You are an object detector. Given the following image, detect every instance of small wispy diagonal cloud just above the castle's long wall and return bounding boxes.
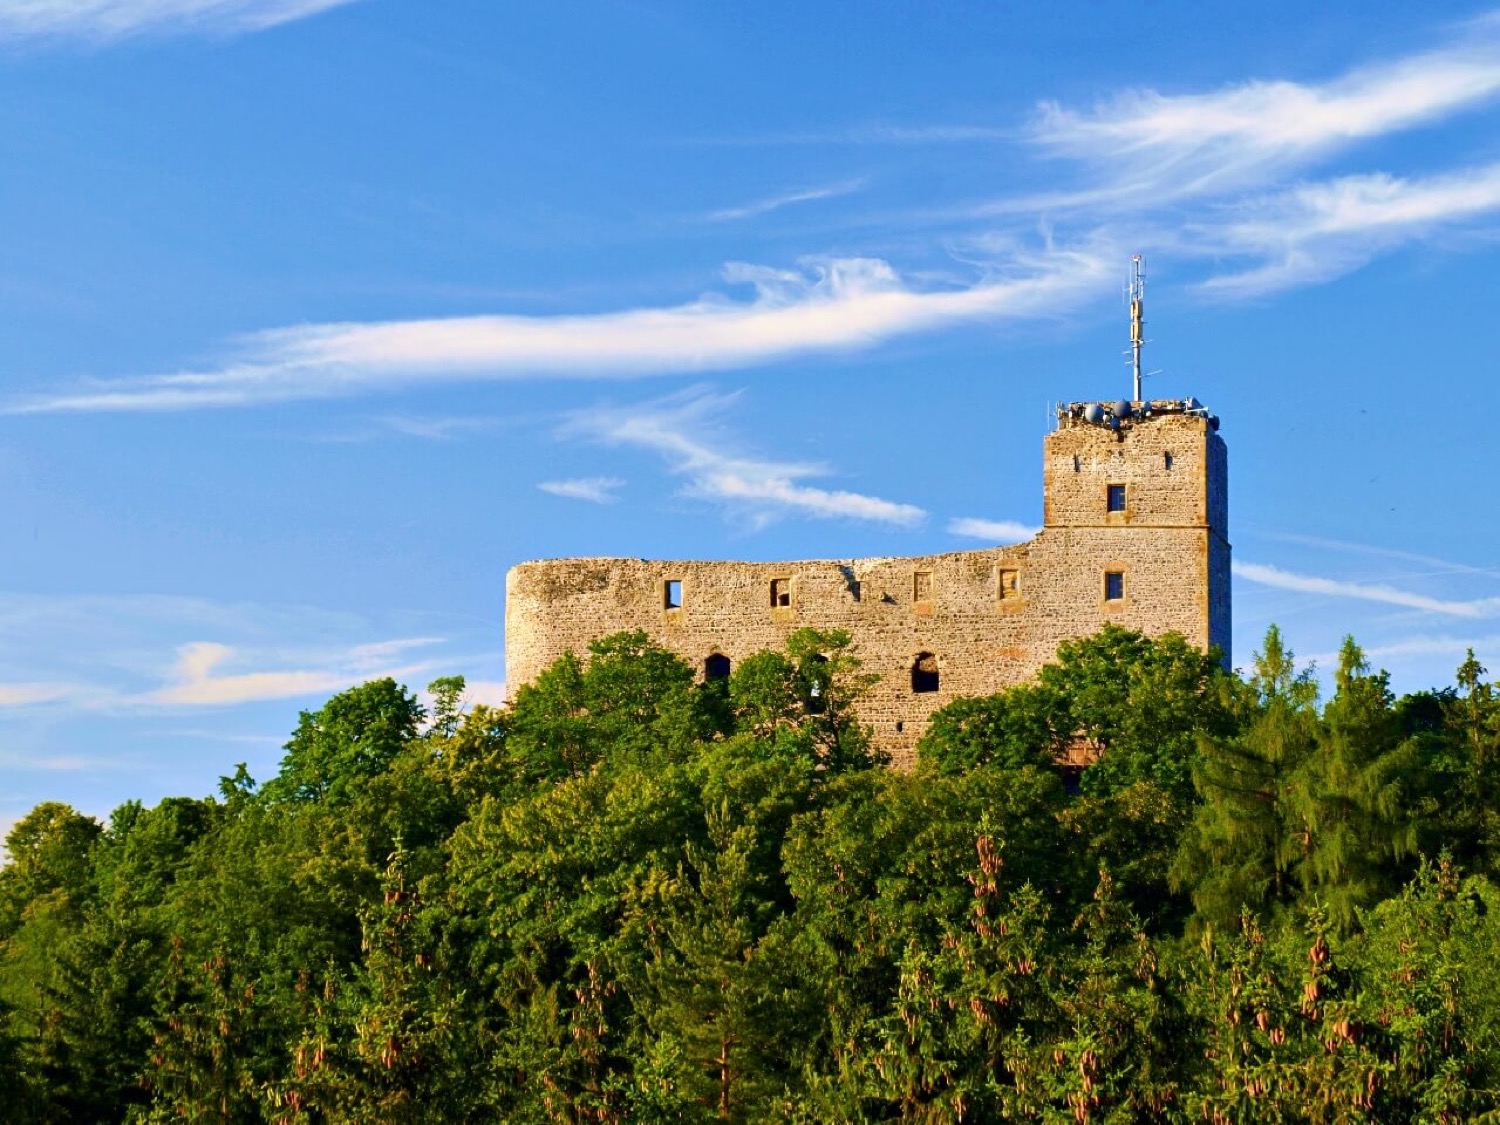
[564,390,927,527]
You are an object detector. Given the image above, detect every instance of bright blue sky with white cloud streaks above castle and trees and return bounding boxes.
[0,0,1500,828]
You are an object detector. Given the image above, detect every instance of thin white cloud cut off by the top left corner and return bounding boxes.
[0,0,354,42]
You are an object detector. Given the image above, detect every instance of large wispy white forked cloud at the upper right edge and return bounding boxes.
[1002,17,1500,300]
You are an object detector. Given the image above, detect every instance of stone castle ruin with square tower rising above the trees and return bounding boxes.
[506,399,1230,765]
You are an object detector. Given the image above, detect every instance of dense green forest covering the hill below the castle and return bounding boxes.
[0,627,1500,1125]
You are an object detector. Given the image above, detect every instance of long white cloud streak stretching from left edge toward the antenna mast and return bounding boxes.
[5,251,1112,414]
